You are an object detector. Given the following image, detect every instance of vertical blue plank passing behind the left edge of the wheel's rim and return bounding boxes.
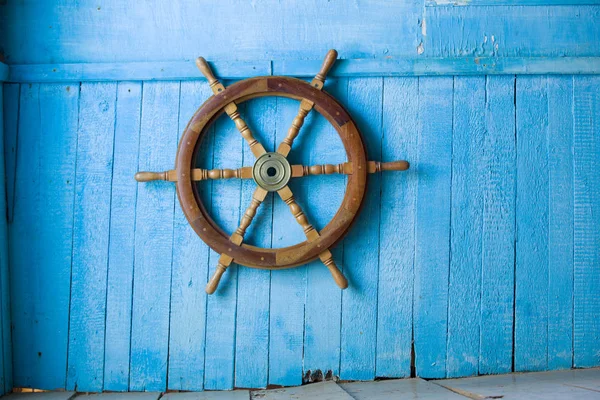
[168,81,212,390]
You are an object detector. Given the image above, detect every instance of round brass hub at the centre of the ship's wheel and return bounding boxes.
[252,153,292,192]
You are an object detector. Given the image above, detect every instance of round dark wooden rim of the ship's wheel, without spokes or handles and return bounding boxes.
[175,76,367,269]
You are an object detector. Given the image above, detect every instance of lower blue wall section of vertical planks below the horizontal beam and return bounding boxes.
[4,76,600,391]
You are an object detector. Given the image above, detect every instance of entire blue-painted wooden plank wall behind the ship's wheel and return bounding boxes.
[0,0,600,391]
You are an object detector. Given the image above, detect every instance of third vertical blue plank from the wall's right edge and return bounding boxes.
[514,77,549,371]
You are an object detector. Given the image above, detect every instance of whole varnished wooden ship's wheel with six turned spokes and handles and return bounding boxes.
[136,50,408,294]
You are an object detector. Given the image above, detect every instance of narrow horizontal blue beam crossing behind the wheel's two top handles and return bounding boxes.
[0,57,600,82]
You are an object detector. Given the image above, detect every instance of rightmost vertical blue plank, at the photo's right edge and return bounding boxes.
[573,77,600,368]
